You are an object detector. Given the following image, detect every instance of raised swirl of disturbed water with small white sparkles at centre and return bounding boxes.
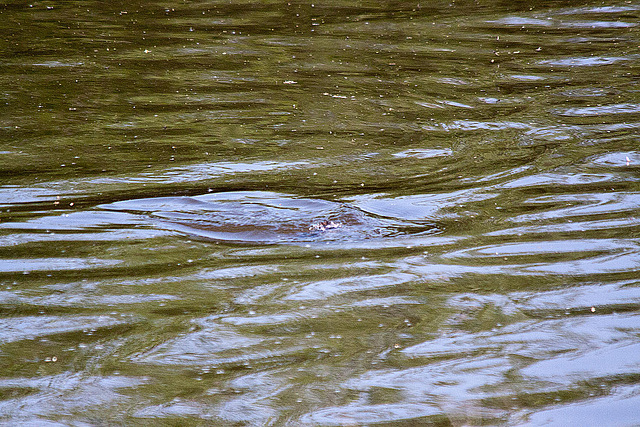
[100,191,433,243]
